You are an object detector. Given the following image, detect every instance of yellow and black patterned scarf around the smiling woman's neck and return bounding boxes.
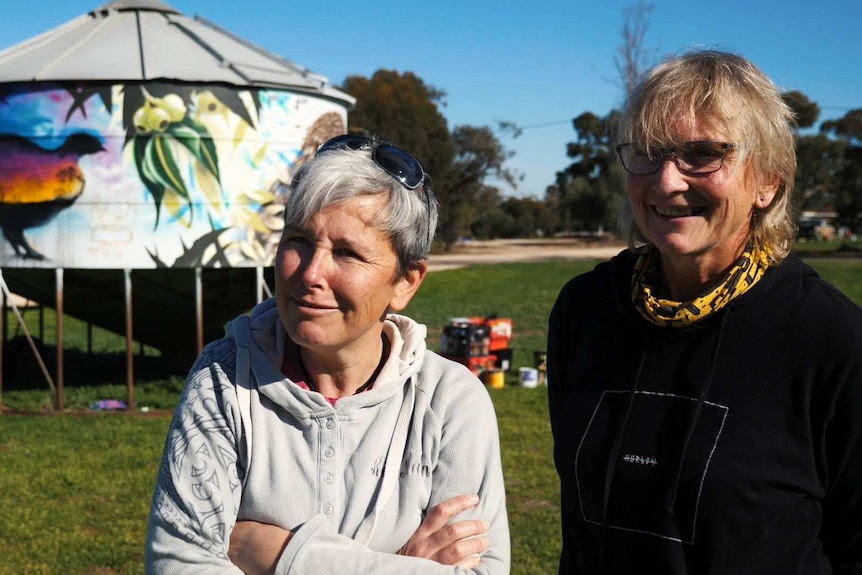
[632,246,769,327]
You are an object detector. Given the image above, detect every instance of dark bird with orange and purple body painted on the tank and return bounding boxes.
[0,132,105,260]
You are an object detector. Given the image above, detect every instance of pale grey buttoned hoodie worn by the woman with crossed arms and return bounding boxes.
[146,299,510,575]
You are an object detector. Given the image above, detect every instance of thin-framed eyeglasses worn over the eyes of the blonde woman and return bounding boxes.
[617,142,736,176]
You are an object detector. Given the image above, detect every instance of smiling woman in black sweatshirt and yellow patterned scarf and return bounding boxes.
[547,50,862,575]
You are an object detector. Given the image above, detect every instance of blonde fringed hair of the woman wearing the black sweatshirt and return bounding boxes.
[616,50,796,263]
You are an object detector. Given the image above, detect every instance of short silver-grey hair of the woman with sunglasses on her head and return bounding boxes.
[284,148,439,278]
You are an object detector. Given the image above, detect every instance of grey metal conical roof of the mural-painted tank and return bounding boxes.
[0,0,355,105]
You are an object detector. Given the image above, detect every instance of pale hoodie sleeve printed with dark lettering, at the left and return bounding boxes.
[145,357,244,575]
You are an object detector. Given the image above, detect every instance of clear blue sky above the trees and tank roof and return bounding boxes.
[0,0,862,198]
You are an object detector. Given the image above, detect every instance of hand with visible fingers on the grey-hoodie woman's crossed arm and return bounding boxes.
[398,495,490,569]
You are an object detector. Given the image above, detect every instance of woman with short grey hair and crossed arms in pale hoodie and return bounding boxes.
[146,135,509,575]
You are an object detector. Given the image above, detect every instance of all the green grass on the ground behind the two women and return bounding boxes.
[0,258,862,575]
